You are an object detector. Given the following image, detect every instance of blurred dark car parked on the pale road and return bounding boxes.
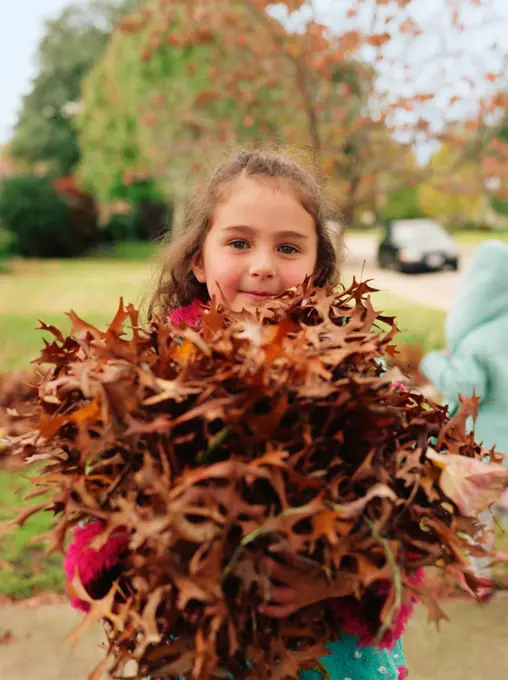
[378,219,459,273]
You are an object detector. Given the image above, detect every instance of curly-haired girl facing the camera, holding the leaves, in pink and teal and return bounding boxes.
[65,151,420,680]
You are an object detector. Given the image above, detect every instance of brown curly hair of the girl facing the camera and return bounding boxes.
[148,149,341,319]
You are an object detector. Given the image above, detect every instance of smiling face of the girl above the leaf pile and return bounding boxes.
[192,178,318,311]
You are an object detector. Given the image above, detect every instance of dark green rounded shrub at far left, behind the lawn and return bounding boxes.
[0,175,98,257]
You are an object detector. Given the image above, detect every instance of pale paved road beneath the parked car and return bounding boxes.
[344,236,474,311]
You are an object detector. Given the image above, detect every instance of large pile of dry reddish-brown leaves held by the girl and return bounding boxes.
[6,282,508,680]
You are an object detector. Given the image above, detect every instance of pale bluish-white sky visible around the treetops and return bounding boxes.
[0,0,508,144]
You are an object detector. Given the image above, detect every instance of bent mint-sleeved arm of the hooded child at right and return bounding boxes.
[420,352,487,403]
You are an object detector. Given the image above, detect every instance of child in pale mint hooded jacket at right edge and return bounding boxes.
[420,241,508,599]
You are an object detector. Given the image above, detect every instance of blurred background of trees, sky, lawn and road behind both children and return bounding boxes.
[0,0,508,680]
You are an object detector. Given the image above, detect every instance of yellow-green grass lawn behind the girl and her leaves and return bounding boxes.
[0,249,443,597]
